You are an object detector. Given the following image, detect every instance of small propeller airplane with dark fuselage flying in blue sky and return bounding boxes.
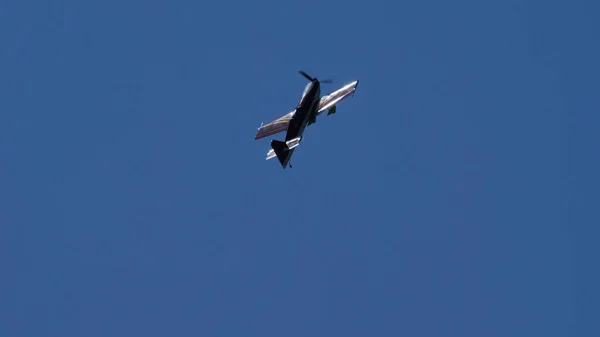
[254,70,358,169]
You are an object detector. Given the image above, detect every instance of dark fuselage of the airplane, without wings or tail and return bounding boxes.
[285,80,321,142]
